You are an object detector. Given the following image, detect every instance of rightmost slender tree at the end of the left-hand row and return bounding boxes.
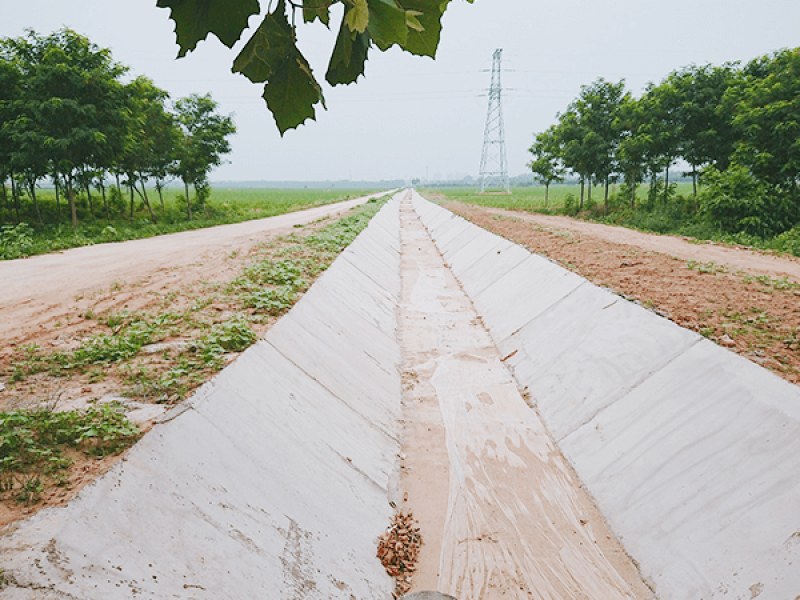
[174,94,236,219]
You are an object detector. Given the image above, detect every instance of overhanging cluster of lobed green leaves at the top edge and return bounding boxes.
[157,0,473,135]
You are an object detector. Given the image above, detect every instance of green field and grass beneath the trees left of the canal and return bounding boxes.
[0,187,388,260]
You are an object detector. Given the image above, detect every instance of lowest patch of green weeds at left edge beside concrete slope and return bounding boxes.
[0,404,140,503]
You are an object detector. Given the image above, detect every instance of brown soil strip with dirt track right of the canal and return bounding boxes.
[438,196,800,384]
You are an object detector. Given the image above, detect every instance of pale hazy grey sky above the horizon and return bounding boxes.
[0,0,800,181]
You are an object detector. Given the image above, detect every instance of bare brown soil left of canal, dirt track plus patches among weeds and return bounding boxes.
[0,198,376,528]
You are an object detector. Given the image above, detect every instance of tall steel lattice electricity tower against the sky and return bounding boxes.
[479,48,511,194]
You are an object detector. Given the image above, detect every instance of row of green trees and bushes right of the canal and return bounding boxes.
[530,50,800,235]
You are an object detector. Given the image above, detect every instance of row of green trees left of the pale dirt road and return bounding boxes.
[0,29,236,226]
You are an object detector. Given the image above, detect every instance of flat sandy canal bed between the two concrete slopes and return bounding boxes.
[399,201,651,600]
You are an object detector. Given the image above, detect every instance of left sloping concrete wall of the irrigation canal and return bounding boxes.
[0,197,401,600]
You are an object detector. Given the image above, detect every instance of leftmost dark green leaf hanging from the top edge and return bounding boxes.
[156,0,259,57]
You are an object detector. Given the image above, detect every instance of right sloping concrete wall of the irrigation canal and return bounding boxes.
[414,195,800,600]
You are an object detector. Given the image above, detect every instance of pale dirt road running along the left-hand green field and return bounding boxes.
[0,196,378,347]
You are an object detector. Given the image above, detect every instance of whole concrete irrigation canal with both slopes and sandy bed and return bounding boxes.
[0,191,800,600]
